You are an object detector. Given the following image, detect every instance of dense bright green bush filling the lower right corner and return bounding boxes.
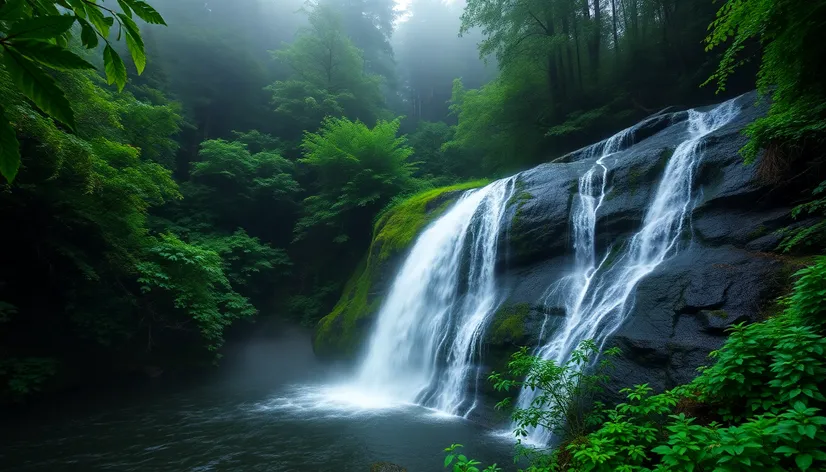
[448,294,826,472]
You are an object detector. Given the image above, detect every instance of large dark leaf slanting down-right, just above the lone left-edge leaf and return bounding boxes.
[3,49,75,130]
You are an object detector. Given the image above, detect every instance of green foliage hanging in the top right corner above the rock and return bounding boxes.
[706,0,826,162]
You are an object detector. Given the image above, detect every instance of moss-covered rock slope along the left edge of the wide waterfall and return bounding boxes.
[313,180,488,357]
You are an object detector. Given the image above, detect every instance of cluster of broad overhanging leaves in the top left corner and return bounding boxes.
[0,0,165,182]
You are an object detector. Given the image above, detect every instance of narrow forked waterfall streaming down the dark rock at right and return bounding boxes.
[517,100,738,444]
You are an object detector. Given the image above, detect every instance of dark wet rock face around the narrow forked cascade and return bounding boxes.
[485,89,792,399]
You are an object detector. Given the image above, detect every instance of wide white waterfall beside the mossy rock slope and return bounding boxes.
[355,176,516,415]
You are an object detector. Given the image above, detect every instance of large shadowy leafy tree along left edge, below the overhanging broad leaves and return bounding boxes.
[0,69,188,395]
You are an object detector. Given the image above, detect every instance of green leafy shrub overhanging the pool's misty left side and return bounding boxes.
[137,234,256,351]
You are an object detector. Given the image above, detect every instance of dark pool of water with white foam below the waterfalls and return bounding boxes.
[0,329,513,472]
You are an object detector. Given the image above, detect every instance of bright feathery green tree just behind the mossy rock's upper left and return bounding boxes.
[295,118,414,243]
